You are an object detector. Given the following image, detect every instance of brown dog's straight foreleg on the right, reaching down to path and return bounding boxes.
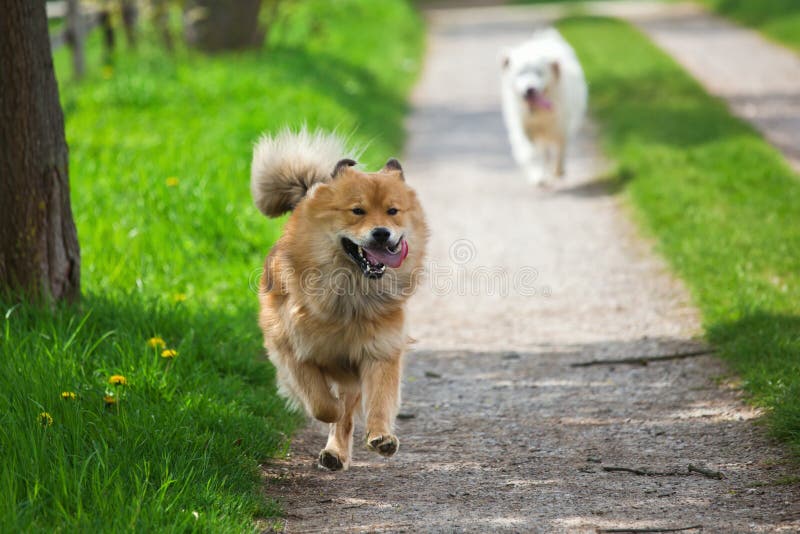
[361,357,401,456]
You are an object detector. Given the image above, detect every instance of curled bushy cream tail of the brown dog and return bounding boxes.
[250,126,360,217]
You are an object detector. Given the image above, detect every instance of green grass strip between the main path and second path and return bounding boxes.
[559,18,800,453]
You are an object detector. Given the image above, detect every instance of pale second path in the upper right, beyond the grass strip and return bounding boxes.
[591,2,800,172]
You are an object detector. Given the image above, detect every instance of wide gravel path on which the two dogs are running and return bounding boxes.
[265,8,800,532]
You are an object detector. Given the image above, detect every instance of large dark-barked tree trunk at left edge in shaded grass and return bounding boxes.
[0,0,80,301]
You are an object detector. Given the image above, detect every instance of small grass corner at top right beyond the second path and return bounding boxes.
[700,0,800,51]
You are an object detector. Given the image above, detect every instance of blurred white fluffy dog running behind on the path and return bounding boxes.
[502,28,588,184]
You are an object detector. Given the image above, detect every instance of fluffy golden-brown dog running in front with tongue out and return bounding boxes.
[251,129,428,470]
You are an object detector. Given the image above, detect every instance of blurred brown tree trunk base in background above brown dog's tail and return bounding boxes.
[183,0,264,52]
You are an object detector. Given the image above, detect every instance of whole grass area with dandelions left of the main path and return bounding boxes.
[0,0,423,532]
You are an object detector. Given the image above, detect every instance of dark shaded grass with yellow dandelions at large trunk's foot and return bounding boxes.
[0,295,299,531]
